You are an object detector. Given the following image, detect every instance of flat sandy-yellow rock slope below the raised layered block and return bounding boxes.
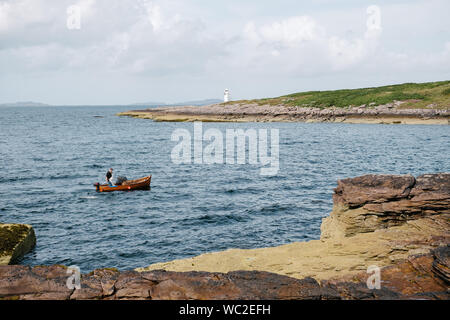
[138,217,449,280]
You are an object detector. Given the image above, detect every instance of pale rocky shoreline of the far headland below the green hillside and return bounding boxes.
[118,101,450,125]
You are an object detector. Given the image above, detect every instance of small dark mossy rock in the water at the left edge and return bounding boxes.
[0,223,36,265]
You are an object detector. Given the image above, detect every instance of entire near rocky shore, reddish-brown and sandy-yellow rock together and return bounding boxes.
[0,173,450,300]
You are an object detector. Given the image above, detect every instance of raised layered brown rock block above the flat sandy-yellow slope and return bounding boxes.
[321,173,450,239]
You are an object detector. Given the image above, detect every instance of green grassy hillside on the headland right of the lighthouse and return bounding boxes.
[235,81,450,109]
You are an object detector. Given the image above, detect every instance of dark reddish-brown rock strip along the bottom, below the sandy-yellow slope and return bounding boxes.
[0,247,450,300]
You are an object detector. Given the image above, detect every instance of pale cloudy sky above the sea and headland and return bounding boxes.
[0,0,450,105]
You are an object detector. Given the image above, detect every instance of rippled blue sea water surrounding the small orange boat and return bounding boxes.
[0,107,450,272]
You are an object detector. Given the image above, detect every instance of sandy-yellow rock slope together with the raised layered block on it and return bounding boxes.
[138,173,450,280]
